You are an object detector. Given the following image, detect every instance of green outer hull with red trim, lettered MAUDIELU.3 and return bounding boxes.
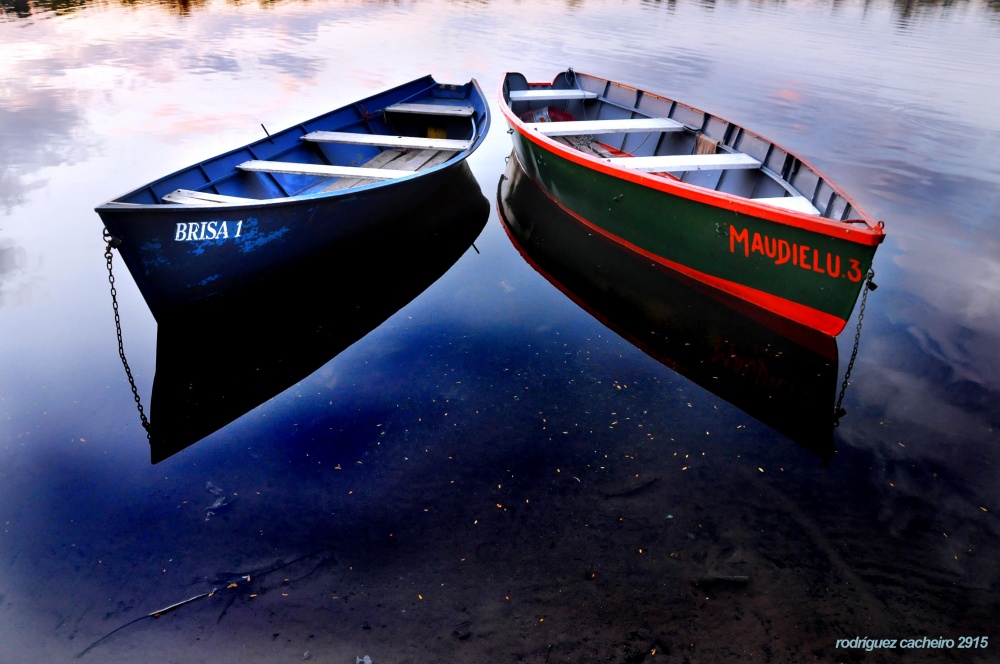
[501,71,883,336]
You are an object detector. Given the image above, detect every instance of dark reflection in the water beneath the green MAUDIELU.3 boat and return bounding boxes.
[497,157,838,463]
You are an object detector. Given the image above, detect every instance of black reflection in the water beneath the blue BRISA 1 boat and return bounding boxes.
[149,164,490,463]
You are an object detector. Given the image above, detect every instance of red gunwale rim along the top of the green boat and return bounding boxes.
[498,72,885,249]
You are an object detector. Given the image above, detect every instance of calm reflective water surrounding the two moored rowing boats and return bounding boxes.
[0,0,1000,664]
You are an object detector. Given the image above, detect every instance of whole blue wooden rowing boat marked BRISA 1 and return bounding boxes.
[96,76,490,319]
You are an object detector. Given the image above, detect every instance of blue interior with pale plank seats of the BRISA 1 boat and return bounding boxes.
[122,85,484,205]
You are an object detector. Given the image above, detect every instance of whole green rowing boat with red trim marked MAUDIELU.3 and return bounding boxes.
[499,69,885,336]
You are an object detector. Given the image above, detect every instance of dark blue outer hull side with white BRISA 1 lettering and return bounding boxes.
[101,169,463,319]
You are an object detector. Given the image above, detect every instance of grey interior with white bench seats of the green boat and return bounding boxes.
[503,70,864,223]
